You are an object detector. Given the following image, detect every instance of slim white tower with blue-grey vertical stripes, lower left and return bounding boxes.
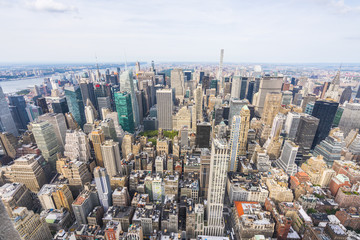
[94,167,112,211]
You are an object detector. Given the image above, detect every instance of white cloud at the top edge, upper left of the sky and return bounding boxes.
[25,0,78,13]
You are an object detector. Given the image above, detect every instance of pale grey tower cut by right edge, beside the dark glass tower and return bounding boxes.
[339,103,360,136]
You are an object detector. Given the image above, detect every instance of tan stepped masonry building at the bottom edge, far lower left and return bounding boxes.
[12,207,52,240]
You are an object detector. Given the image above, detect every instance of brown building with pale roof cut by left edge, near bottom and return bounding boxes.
[0,183,34,217]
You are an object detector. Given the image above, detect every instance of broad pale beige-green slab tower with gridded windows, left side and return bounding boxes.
[31,121,59,169]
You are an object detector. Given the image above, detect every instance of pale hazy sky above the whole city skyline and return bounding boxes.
[0,0,360,63]
